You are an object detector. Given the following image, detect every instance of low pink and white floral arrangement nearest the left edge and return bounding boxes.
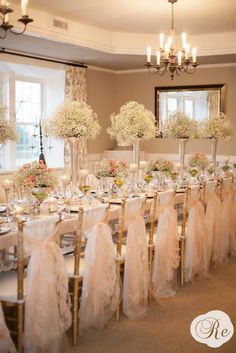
[13,161,57,189]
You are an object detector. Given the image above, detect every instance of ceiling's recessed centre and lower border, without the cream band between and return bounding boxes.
[0,0,236,70]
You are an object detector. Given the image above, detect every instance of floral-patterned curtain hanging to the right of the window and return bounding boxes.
[64,65,87,172]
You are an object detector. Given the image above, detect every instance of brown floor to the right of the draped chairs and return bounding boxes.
[73,257,236,353]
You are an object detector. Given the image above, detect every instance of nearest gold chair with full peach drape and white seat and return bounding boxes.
[0,216,71,353]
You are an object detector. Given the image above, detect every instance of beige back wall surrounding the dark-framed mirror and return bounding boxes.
[88,66,236,155]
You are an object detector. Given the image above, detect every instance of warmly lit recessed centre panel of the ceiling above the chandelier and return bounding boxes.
[30,0,236,34]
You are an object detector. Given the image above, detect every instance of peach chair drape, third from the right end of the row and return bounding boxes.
[184,186,207,282]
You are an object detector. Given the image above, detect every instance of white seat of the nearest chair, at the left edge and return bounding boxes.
[0,271,27,303]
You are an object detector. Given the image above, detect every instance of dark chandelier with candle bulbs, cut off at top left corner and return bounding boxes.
[0,0,33,39]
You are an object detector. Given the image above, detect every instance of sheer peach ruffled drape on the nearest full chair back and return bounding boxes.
[24,217,71,353]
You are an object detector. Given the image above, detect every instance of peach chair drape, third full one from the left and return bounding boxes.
[123,197,148,319]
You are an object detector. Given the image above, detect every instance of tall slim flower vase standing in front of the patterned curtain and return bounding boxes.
[68,137,80,198]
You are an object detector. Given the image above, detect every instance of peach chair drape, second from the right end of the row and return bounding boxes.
[205,181,219,268]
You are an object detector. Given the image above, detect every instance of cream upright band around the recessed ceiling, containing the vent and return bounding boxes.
[14,5,236,56]
